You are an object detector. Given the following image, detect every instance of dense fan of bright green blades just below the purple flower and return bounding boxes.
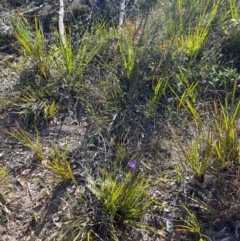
[87,172,153,222]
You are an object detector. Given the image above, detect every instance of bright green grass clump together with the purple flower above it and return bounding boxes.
[81,160,163,240]
